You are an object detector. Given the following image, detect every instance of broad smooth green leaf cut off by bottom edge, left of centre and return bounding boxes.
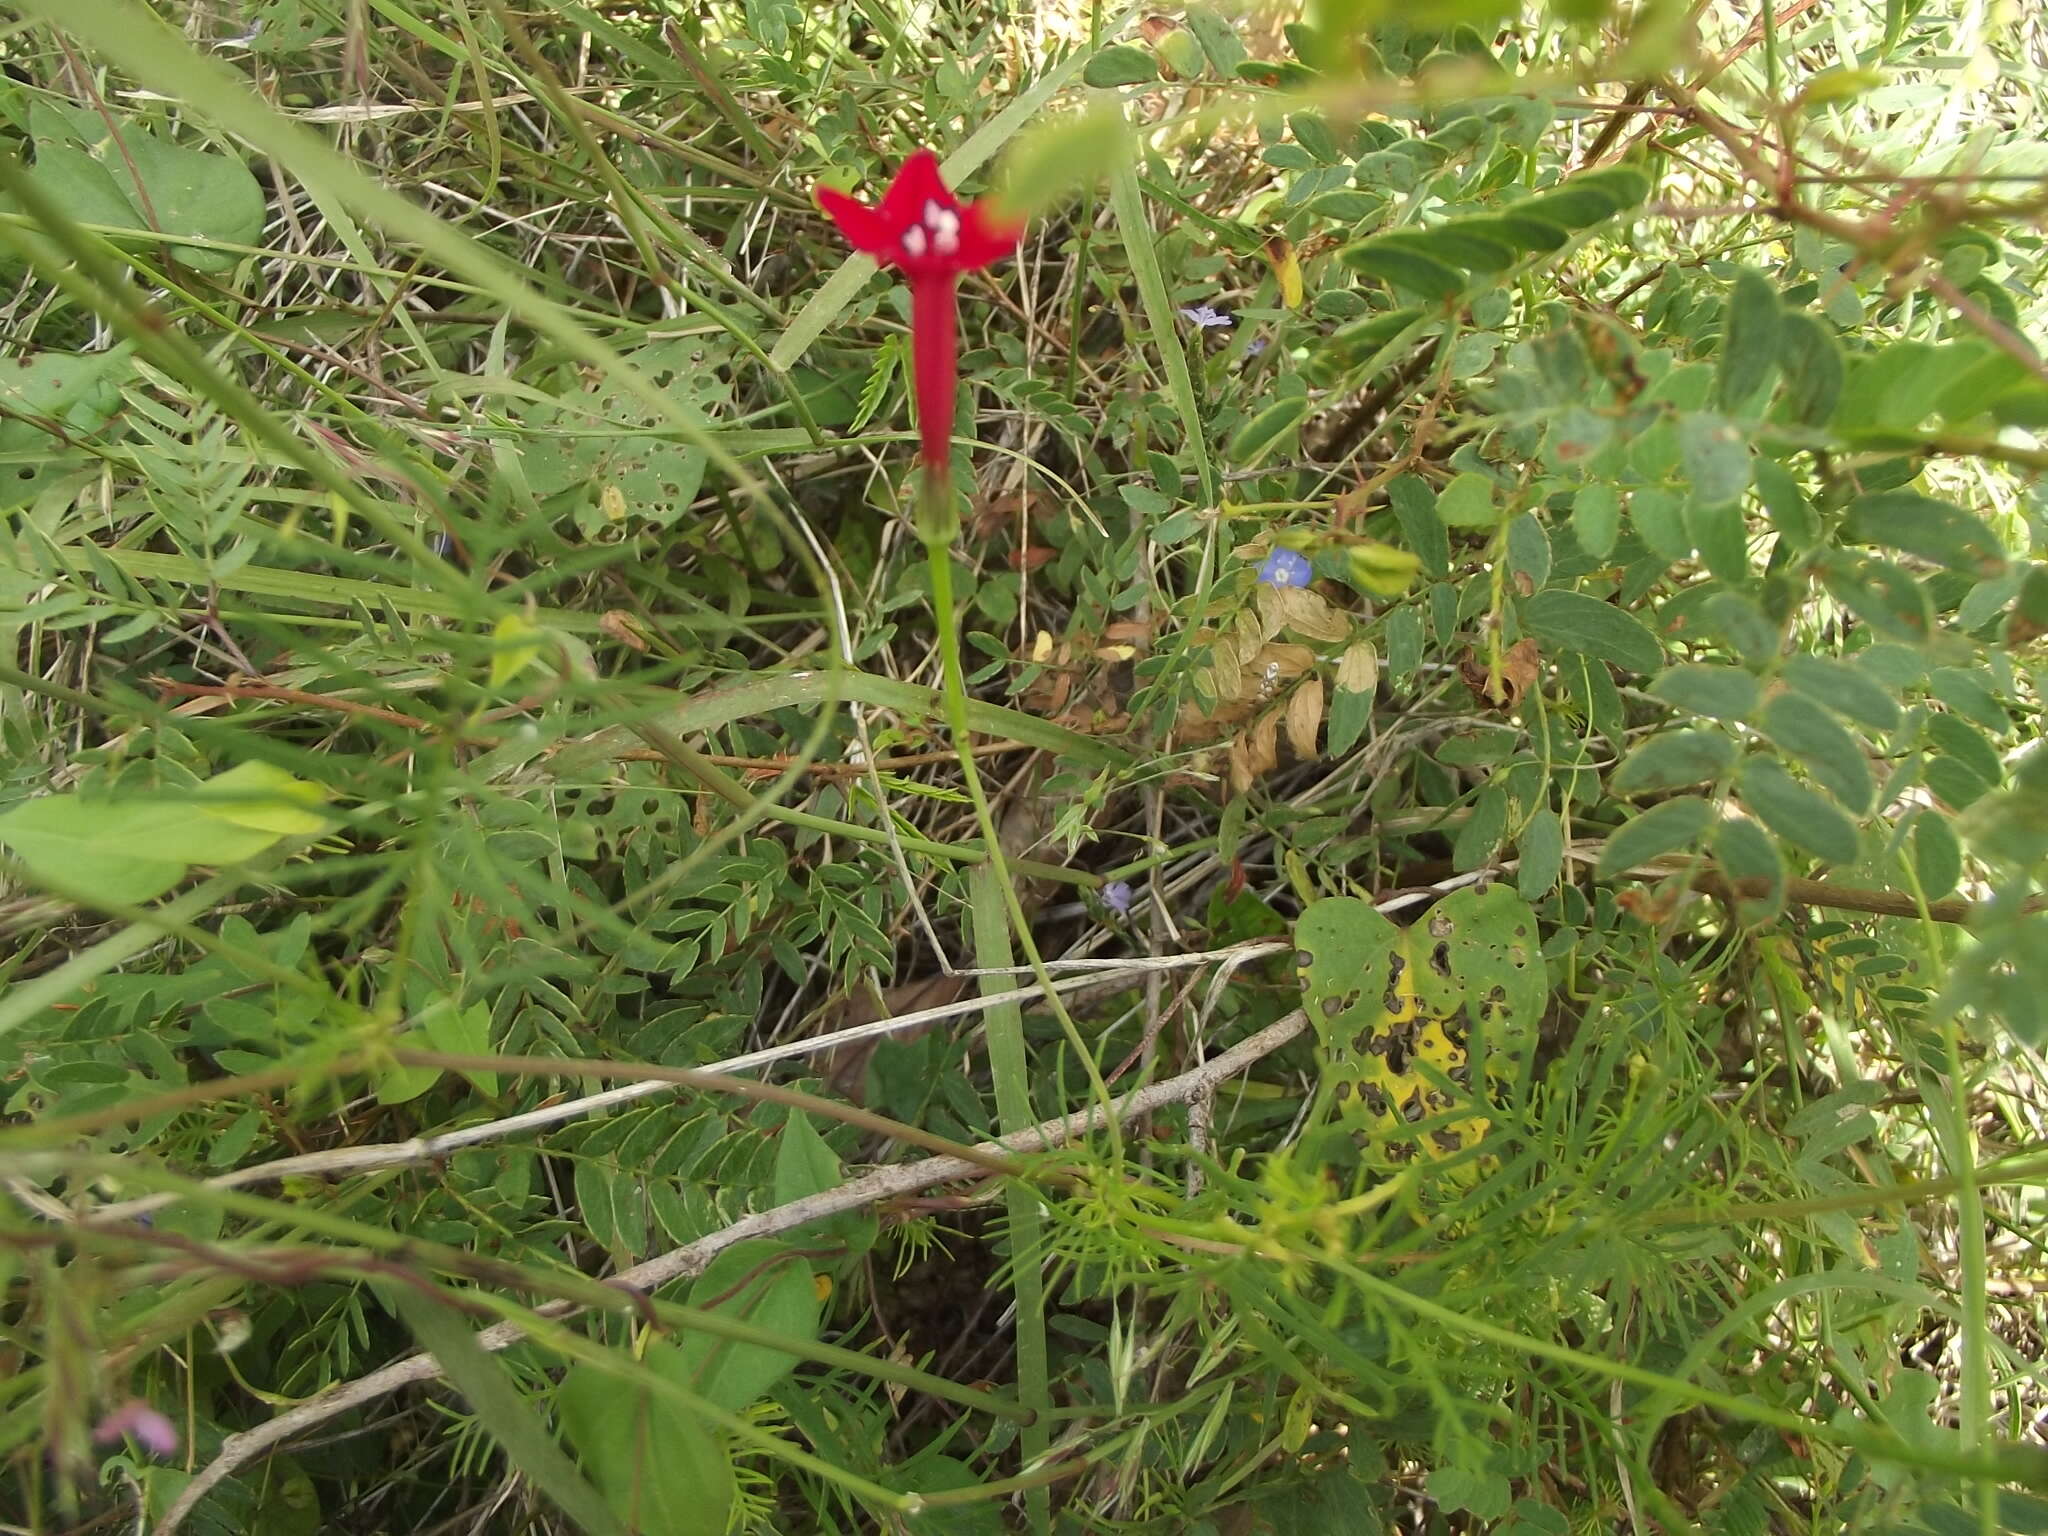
[555,1339,733,1536]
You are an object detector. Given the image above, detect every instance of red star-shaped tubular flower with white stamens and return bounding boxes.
[817,150,1024,481]
